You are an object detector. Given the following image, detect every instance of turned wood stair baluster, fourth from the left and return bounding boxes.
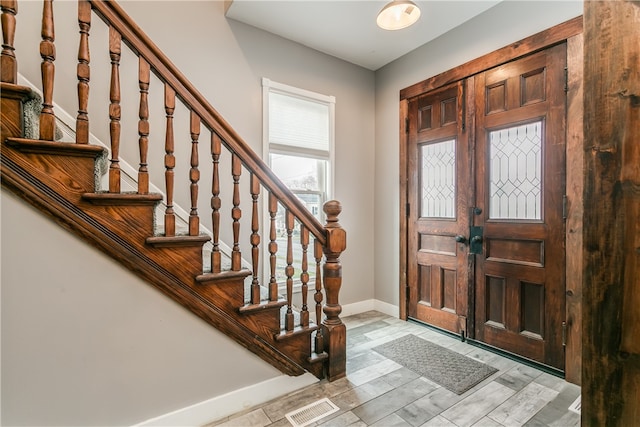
[109,27,122,193]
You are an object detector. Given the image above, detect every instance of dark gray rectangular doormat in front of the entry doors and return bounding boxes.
[373,334,498,394]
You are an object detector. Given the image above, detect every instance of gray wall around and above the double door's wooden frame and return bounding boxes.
[373,1,582,305]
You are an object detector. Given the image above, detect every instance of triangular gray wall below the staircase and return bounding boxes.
[1,195,280,426]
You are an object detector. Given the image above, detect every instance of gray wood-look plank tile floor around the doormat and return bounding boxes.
[207,311,580,427]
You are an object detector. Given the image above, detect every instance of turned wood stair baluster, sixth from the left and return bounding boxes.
[164,83,176,237]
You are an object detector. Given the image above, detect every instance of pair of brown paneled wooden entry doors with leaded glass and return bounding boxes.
[406,44,566,370]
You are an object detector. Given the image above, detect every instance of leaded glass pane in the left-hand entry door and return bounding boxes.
[420,139,456,218]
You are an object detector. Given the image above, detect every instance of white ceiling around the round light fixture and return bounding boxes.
[227,0,502,70]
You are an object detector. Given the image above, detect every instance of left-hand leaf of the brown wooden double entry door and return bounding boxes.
[407,83,470,333]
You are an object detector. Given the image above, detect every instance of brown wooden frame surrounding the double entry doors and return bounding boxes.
[399,16,583,384]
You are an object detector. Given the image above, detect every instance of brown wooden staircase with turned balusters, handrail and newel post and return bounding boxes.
[0,0,346,381]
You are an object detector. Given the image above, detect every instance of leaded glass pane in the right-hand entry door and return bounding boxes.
[489,121,542,220]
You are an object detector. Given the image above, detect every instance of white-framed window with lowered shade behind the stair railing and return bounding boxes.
[262,78,335,283]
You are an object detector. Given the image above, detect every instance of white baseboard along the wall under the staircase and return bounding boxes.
[135,373,319,427]
